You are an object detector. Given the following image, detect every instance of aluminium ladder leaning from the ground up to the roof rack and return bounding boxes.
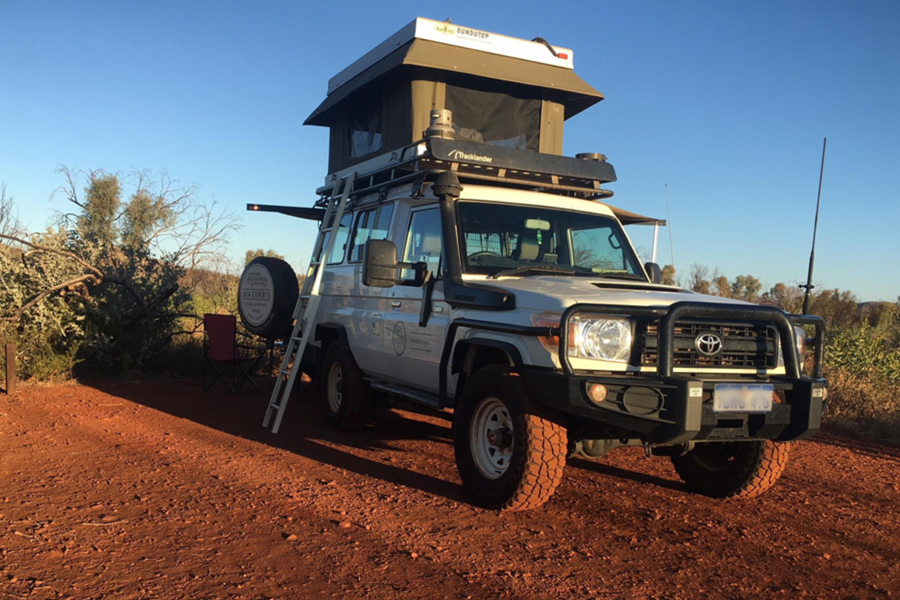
[263,173,356,433]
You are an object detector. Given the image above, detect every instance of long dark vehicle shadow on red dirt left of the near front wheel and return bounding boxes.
[88,380,469,502]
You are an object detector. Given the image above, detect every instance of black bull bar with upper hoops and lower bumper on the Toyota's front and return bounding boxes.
[522,302,827,444]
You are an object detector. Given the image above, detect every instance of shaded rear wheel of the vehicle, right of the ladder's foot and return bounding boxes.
[322,343,372,430]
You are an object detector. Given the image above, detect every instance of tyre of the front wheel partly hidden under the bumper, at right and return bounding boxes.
[672,440,791,500]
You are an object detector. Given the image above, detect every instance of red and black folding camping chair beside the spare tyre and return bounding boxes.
[203,314,265,394]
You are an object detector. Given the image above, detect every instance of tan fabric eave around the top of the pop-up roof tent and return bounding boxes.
[303,39,603,127]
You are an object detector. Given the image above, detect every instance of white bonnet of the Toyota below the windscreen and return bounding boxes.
[473,276,748,312]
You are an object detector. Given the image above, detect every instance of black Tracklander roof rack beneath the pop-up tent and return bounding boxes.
[316,137,616,203]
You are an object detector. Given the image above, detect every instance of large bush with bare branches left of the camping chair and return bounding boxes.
[0,169,236,379]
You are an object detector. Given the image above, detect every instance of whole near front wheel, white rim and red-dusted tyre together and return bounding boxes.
[453,365,567,510]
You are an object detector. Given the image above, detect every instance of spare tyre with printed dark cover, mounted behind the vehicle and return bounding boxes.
[238,256,300,340]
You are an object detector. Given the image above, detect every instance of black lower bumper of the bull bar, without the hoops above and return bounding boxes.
[522,368,826,445]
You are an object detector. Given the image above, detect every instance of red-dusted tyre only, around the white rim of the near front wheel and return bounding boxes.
[453,365,567,511]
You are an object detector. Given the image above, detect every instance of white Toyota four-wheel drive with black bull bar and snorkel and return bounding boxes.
[241,19,825,510]
